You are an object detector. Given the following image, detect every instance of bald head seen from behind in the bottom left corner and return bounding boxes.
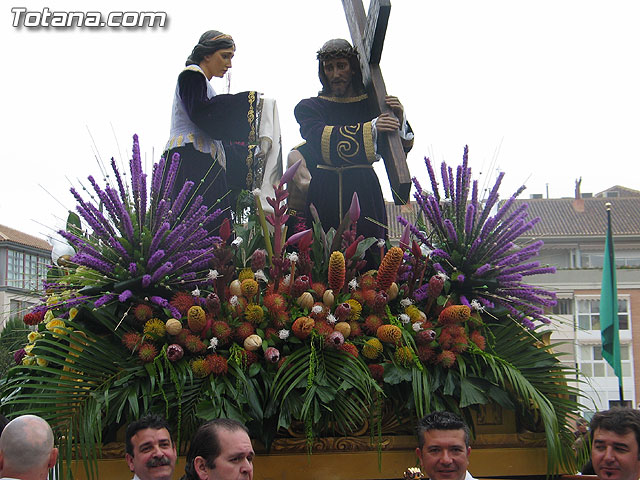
[0,415,58,480]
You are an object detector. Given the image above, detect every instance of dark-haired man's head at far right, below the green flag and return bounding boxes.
[590,407,640,480]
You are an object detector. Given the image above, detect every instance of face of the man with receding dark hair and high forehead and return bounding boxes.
[194,428,255,480]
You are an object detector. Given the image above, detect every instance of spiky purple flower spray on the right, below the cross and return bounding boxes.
[400,147,556,326]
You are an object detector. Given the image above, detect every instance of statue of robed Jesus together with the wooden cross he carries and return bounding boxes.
[289,0,413,242]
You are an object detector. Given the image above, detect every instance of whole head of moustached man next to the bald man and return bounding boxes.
[125,415,177,480]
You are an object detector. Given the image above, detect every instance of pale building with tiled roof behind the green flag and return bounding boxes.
[516,186,640,416]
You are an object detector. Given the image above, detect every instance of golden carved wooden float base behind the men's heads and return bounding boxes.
[76,433,547,480]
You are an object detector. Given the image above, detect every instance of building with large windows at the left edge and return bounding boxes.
[0,225,51,330]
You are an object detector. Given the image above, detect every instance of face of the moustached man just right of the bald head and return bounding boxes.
[125,428,177,480]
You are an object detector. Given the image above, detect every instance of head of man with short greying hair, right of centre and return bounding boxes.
[416,412,474,480]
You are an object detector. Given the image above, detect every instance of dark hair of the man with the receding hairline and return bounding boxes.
[180,418,249,480]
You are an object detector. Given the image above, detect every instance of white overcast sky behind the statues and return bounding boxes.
[0,0,640,240]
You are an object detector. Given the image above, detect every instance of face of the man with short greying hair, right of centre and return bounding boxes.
[416,430,471,480]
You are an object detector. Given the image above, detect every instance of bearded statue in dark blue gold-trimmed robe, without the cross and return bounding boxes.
[288,39,413,244]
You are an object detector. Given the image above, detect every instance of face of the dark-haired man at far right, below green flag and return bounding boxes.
[591,428,640,480]
